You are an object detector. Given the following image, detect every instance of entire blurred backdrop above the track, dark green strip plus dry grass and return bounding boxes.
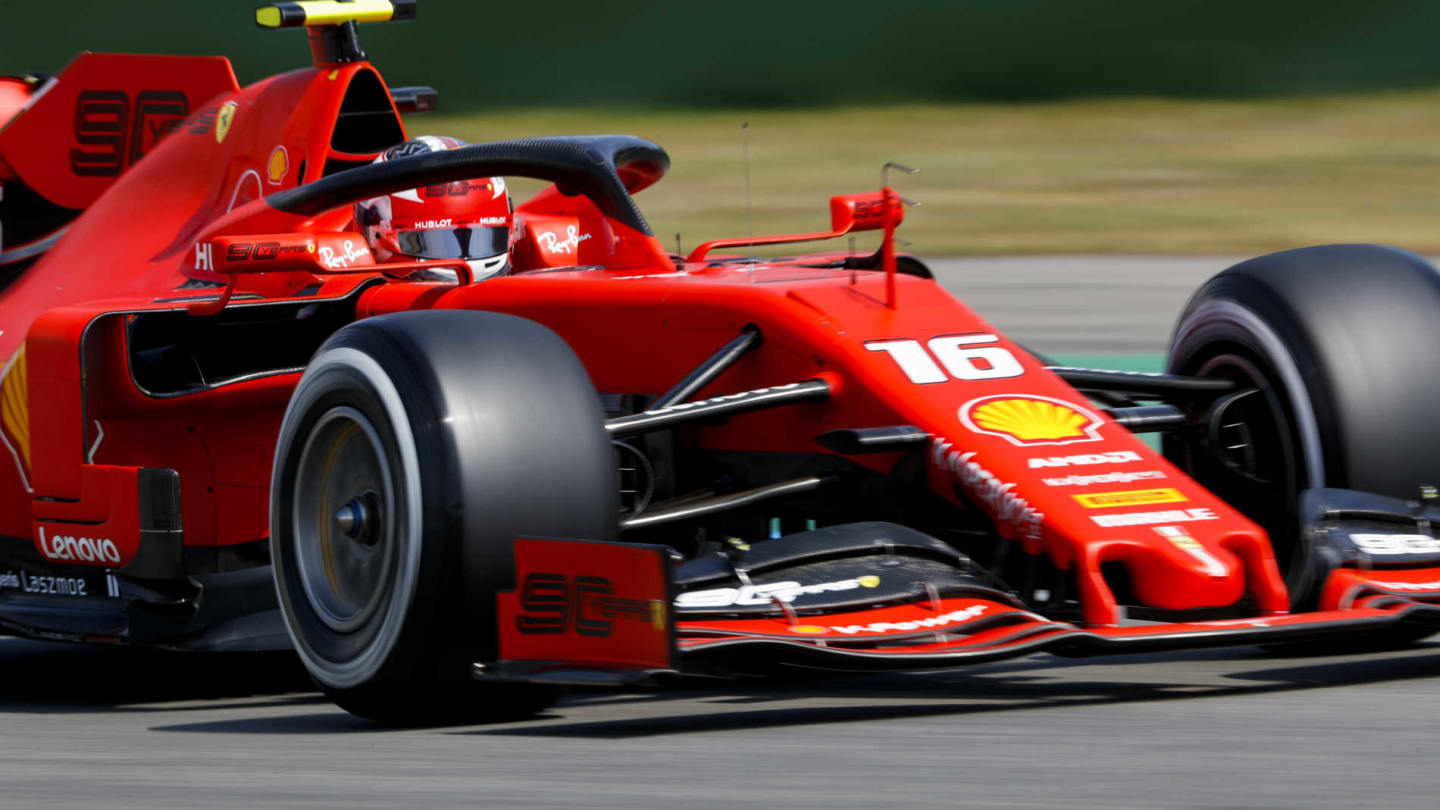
[0,0,1440,255]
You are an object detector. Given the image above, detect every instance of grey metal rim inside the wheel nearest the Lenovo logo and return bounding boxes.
[292,406,400,633]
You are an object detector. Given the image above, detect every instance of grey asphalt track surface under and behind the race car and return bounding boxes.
[0,258,1440,810]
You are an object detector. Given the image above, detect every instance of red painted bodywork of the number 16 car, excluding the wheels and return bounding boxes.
[0,41,1440,660]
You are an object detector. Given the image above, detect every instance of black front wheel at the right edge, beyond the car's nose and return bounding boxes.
[1165,245,1440,628]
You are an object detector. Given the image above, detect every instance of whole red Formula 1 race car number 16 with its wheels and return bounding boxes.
[0,0,1440,722]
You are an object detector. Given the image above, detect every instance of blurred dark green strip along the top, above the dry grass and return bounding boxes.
[0,0,1440,110]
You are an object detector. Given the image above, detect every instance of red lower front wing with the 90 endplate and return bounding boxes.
[489,539,1440,685]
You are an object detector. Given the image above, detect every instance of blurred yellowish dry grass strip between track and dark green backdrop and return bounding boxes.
[412,91,1440,255]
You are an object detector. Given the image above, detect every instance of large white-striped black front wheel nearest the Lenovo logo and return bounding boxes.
[271,310,619,725]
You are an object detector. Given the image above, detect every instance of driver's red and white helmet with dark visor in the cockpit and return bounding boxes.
[354,135,514,281]
